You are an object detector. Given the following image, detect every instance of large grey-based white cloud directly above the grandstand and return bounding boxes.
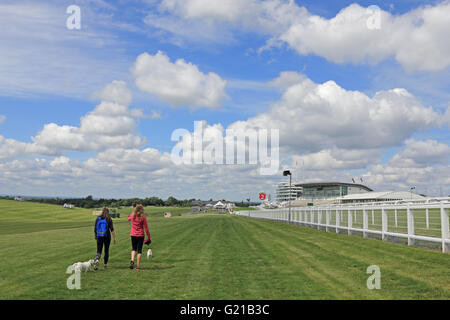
[230,77,443,154]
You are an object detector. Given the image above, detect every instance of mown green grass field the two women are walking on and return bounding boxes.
[0,200,450,300]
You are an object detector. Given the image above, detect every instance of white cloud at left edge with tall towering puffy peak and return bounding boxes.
[0,81,145,159]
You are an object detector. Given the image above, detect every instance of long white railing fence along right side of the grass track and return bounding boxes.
[236,199,450,252]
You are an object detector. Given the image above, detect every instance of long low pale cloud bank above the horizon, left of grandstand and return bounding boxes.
[0,141,275,200]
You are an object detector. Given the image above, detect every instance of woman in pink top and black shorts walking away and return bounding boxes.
[128,204,151,270]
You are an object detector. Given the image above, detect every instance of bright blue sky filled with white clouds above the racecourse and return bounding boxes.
[0,0,450,201]
